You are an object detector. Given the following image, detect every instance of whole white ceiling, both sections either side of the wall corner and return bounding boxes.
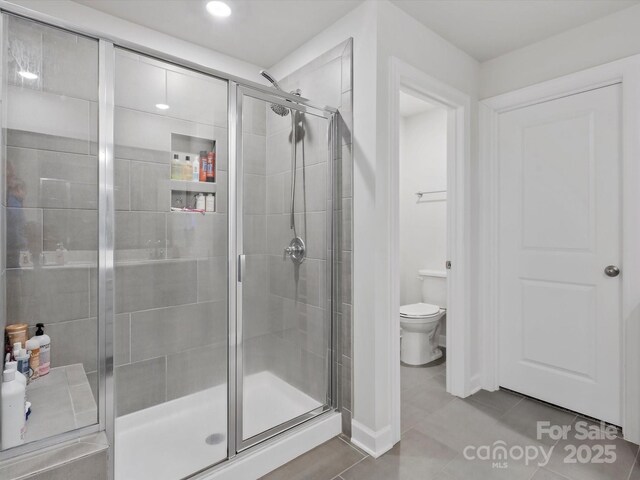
[75,0,640,67]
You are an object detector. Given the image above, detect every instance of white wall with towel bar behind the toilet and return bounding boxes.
[400,108,447,305]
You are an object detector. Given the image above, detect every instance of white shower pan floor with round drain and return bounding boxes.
[115,371,322,480]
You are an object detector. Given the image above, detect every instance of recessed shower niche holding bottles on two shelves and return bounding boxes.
[169,133,217,214]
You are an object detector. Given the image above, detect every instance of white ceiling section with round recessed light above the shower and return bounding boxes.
[74,0,361,67]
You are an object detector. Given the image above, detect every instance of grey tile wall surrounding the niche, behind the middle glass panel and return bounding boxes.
[114,50,228,415]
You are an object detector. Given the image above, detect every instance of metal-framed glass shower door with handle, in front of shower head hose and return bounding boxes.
[236,88,332,450]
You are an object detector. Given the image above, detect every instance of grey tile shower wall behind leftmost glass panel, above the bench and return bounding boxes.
[0,15,98,398]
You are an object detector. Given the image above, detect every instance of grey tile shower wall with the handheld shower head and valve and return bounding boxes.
[265,40,352,436]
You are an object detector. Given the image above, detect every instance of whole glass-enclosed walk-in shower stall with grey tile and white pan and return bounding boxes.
[0,12,338,480]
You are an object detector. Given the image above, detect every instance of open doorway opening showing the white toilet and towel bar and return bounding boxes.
[398,91,450,432]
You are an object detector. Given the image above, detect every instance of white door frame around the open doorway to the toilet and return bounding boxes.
[387,57,480,443]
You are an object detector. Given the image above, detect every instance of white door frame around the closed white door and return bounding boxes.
[478,55,640,443]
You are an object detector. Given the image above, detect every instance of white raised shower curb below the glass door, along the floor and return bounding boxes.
[202,412,342,480]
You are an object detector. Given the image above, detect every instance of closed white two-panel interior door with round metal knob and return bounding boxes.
[499,85,621,425]
